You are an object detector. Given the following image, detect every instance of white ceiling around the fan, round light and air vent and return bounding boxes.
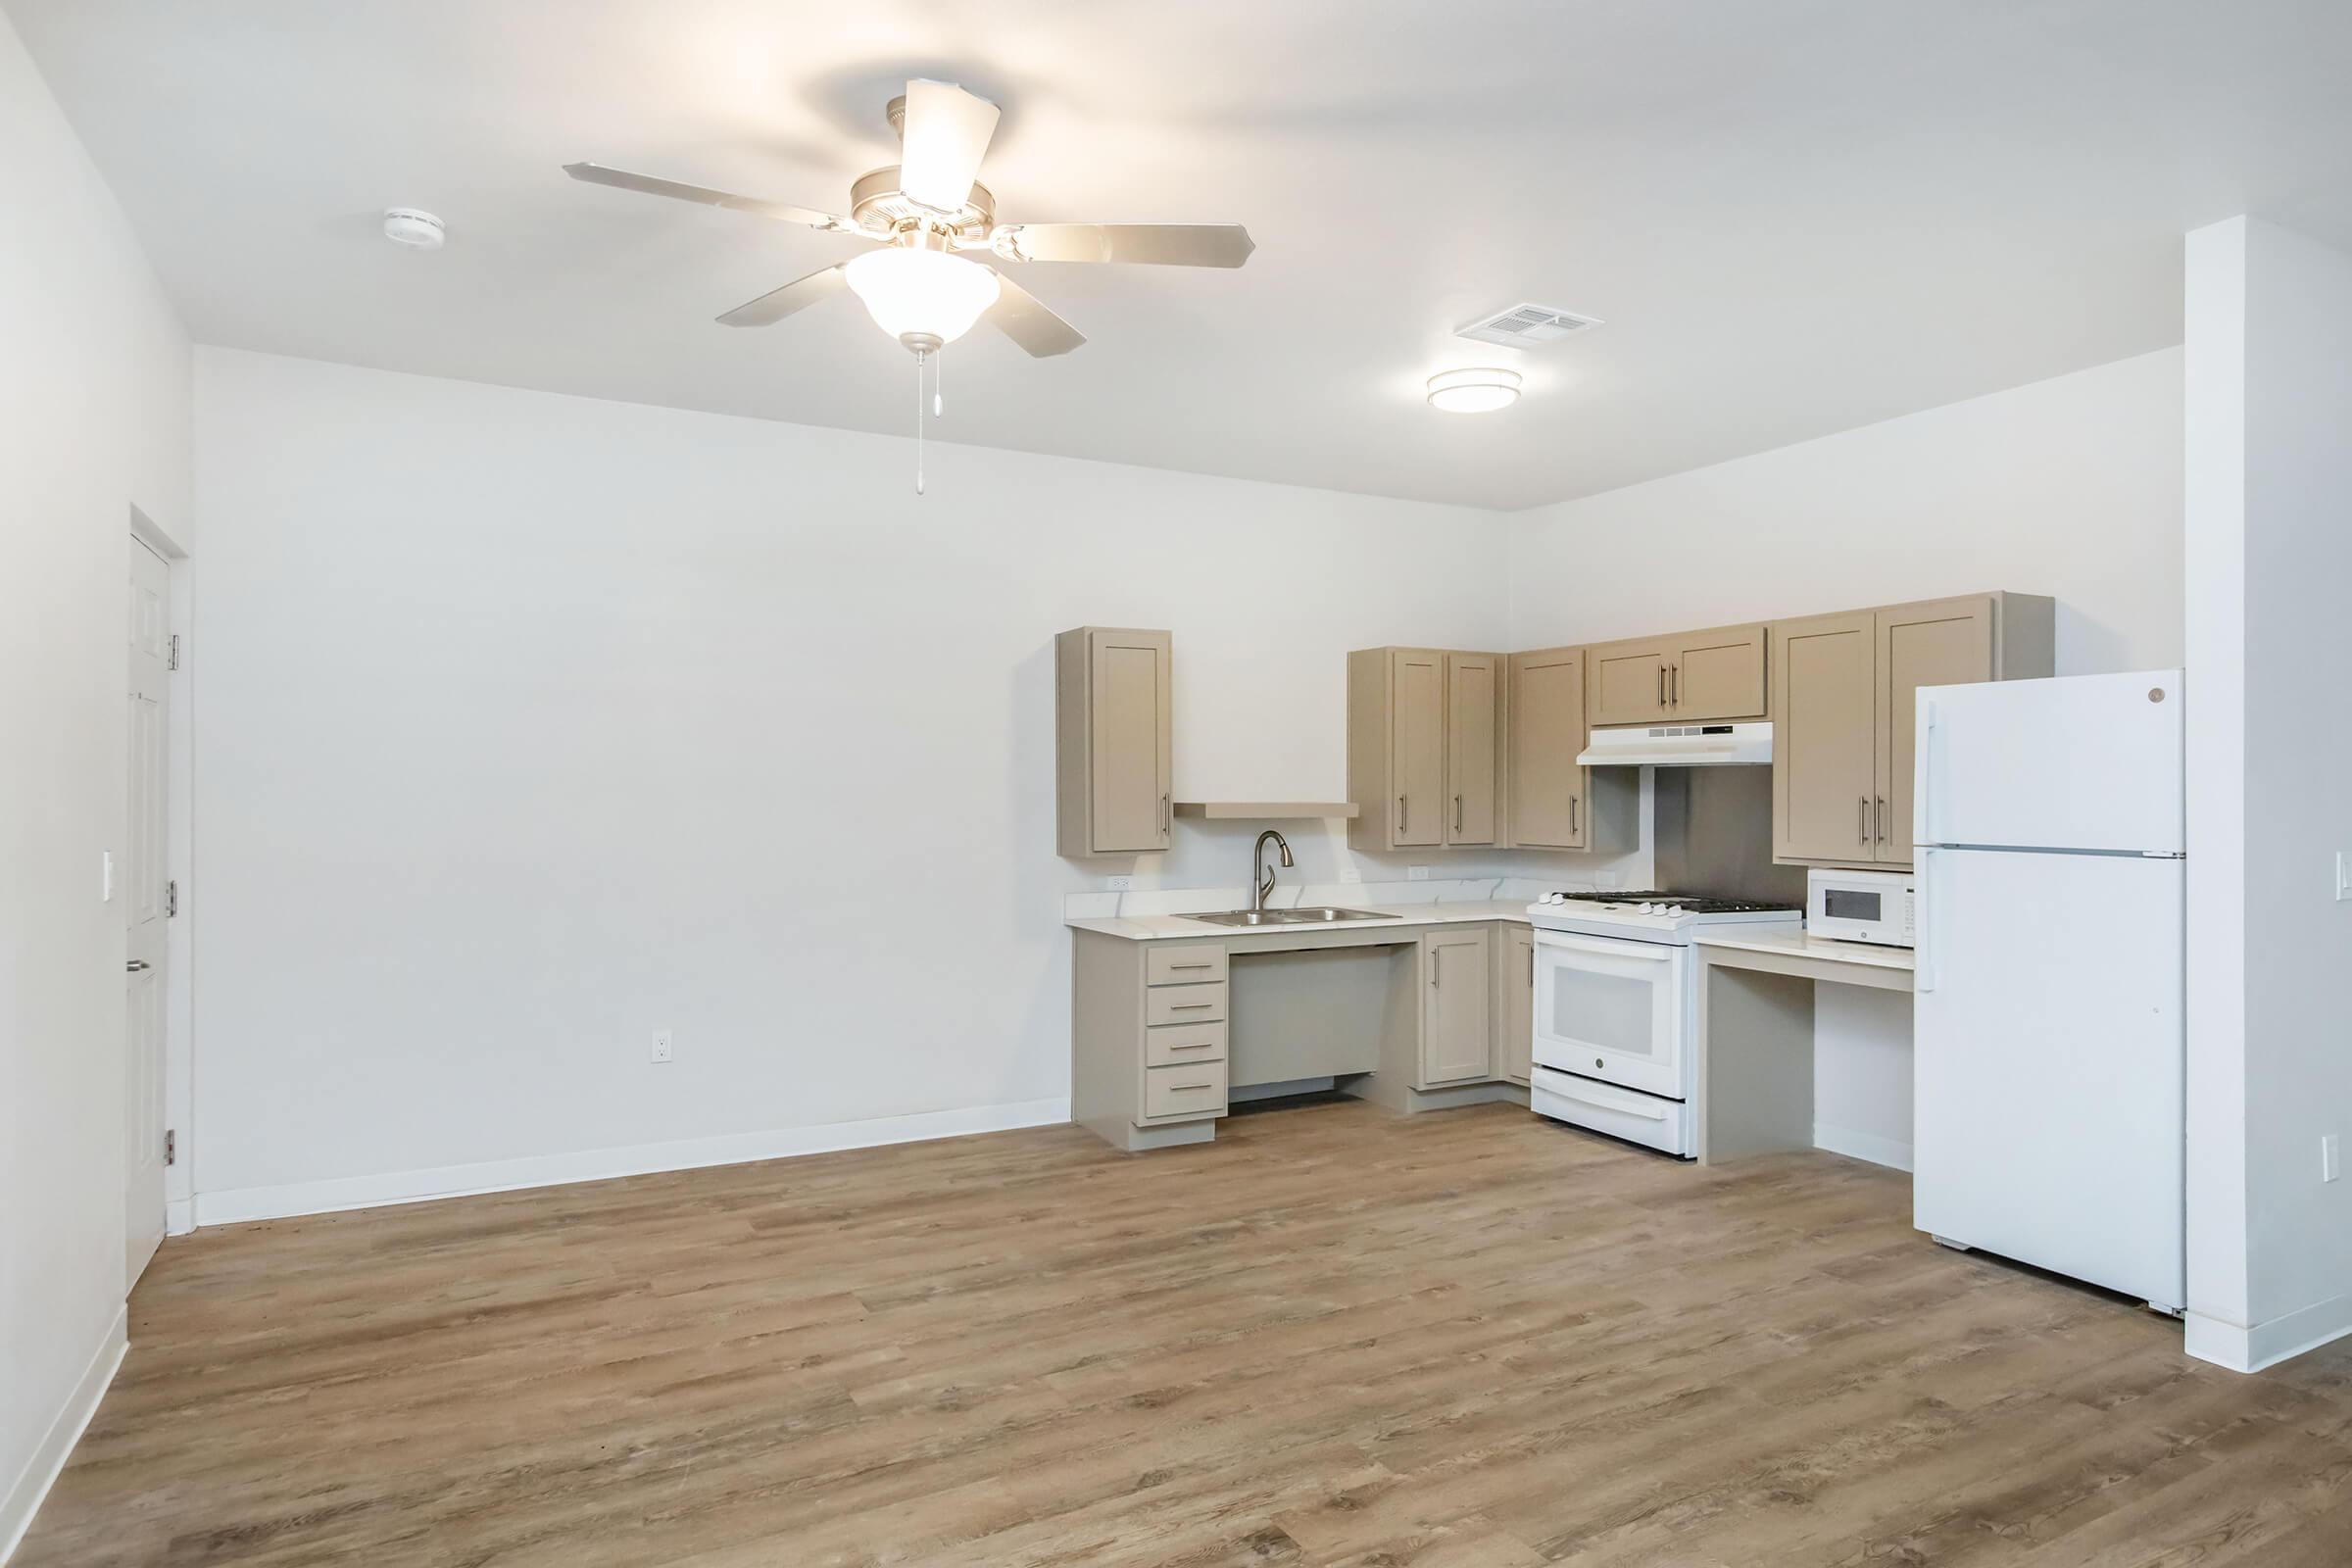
[18,0,2352,508]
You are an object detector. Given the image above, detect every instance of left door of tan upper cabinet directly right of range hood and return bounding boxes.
[1771,609,1880,862]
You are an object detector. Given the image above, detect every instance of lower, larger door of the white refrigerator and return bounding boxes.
[1912,849,2185,1307]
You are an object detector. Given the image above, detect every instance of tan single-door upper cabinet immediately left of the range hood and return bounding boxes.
[1500,649,1642,851]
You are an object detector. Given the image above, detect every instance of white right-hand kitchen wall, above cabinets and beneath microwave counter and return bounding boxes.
[1510,348,2182,1163]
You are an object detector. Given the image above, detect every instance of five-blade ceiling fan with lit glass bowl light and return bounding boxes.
[564,80,1256,365]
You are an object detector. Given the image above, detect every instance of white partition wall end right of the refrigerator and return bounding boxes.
[2187,219,2352,1366]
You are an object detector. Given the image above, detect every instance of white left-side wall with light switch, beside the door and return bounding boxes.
[0,17,188,1554]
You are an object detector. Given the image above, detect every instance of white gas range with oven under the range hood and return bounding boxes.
[1527,891,1804,1159]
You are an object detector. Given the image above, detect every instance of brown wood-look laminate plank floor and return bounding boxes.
[19,1102,2352,1568]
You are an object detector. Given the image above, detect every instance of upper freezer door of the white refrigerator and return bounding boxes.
[1912,670,2187,854]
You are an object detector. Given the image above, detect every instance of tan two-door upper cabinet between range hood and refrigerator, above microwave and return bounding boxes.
[1771,592,2056,867]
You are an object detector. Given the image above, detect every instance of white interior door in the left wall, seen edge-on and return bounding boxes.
[116,538,172,1284]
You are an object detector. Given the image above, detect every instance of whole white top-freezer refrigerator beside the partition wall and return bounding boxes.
[1912,670,2185,1312]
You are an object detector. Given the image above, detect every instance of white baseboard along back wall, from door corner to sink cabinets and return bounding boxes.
[195,1096,1070,1225]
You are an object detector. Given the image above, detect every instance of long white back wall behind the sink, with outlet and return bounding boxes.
[195,346,1543,1220]
